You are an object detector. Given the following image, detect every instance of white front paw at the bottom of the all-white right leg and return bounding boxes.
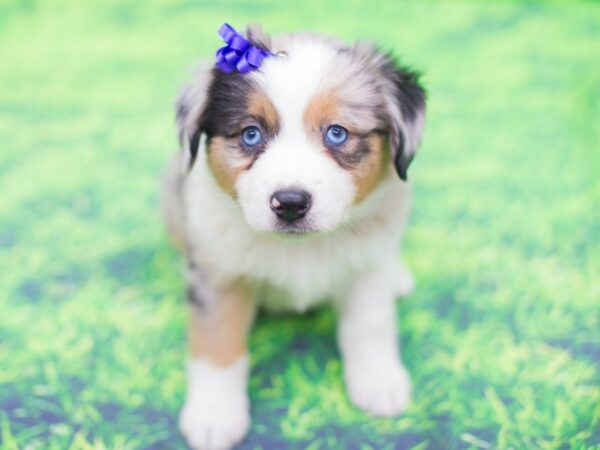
[344,358,411,417]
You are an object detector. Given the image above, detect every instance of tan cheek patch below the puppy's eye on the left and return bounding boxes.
[208,136,246,198]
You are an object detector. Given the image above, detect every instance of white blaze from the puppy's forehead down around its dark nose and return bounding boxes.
[236,38,355,231]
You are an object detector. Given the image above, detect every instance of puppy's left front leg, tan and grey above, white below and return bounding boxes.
[179,273,254,450]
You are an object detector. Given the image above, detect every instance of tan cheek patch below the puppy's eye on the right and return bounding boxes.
[350,134,389,204]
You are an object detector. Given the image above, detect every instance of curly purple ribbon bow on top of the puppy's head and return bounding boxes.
[217,23,271,73]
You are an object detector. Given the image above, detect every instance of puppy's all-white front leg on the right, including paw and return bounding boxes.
[338,262,410,416]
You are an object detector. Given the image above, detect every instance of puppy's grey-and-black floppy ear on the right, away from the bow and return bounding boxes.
[383,59,425,181]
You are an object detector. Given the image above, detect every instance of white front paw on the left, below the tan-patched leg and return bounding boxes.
[179,395,250,450]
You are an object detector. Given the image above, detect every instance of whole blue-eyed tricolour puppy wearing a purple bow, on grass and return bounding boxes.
[163,25,425,449]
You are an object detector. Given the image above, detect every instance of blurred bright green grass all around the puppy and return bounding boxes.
[0,0,600,450]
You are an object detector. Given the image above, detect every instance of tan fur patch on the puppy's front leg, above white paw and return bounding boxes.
[188,282,254,367]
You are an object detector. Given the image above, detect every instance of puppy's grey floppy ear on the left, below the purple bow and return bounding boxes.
[175,66,212,169]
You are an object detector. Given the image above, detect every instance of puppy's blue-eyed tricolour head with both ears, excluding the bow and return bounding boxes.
[178,30,425,233]
